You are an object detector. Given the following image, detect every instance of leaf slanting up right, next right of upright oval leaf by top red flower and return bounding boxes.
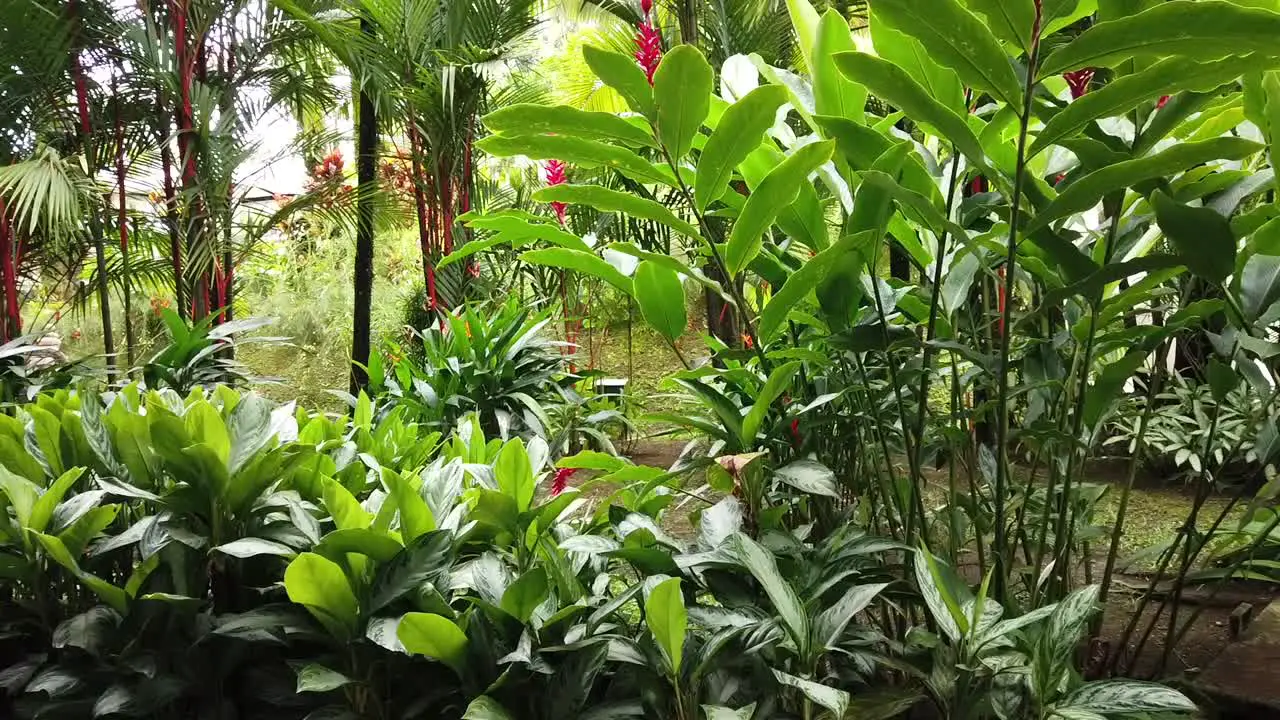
[694,85,787,211]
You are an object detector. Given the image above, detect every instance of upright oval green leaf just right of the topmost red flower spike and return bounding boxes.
[653,45,716,163]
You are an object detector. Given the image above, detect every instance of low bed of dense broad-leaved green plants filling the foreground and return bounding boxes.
[0,386,1193,720]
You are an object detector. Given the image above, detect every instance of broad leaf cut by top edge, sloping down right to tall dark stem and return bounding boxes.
[870,0,1023,109]
